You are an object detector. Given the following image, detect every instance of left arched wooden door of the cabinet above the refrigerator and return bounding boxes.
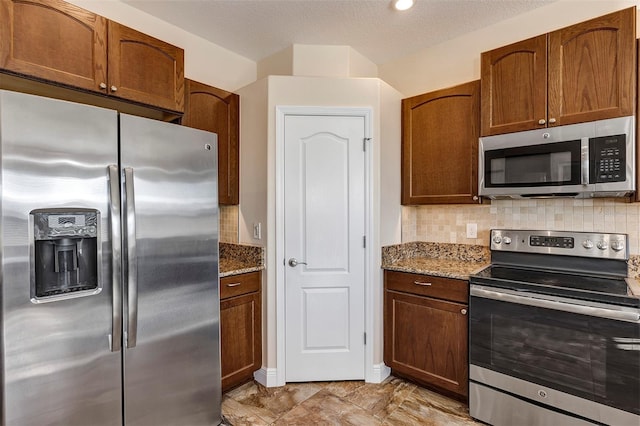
[0,0,107,91]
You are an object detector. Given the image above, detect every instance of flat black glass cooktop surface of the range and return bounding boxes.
[470,265,640,307]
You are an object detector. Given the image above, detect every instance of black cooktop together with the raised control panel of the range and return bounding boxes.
[470,230,640,308]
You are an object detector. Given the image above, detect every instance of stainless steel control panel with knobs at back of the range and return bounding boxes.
[491,229,629,260]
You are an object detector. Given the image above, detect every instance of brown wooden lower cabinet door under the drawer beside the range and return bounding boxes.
[384,291,469,397]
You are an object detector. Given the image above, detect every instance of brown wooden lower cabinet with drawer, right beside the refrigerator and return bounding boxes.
[220,272,262,392]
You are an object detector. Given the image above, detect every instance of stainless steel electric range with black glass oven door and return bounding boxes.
[469,230,640,426]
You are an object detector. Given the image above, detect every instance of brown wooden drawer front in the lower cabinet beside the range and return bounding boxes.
[384,270,469,303]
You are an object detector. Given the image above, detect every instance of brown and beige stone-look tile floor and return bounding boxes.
[222,377,481,426]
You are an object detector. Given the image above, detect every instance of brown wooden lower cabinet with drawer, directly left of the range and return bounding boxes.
[384,271,469,399]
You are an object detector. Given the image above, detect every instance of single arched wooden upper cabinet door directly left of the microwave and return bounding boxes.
[402,81,480,205]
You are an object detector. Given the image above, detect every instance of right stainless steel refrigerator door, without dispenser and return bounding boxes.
[120,114,221,426]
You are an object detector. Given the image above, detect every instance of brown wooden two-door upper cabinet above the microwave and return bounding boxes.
[481,7,636,136]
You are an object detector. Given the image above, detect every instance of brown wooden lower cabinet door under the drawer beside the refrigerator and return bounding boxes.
[220,280,262,392]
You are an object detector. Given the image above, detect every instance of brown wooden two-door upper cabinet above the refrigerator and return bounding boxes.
[0,0,184,112]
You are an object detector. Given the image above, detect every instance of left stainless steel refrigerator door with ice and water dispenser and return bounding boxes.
[0,91,122,425]
